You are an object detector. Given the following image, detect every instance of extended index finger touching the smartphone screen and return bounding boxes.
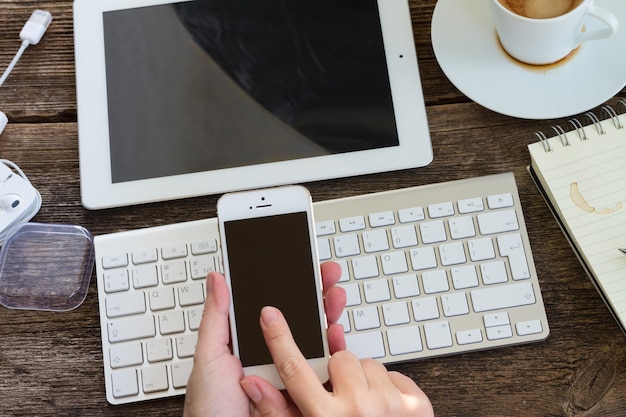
[261,307,329,414]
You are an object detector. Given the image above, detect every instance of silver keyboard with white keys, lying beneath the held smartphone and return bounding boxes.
[95,174,549,404]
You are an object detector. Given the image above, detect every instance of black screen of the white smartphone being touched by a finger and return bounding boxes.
[224,212,324,366]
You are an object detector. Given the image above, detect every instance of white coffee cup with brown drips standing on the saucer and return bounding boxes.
[489,0,619,65]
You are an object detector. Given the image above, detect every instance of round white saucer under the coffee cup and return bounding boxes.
[431,0,626,119]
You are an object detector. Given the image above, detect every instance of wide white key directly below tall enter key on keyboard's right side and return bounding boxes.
[471,282,536,312]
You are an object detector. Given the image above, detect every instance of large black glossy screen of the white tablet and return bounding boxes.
[103,0,399,183]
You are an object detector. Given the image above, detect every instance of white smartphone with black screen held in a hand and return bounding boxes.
[217,186,330,389]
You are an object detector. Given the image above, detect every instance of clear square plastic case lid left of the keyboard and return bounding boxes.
[0,223,94,311]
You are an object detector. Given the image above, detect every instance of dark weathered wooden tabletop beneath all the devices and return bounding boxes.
[0,0,626,416]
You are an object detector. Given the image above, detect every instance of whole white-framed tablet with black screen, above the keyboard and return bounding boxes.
[74,0,432,209]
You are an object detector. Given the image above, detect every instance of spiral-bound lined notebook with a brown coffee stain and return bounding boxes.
[528,100,626,333]
